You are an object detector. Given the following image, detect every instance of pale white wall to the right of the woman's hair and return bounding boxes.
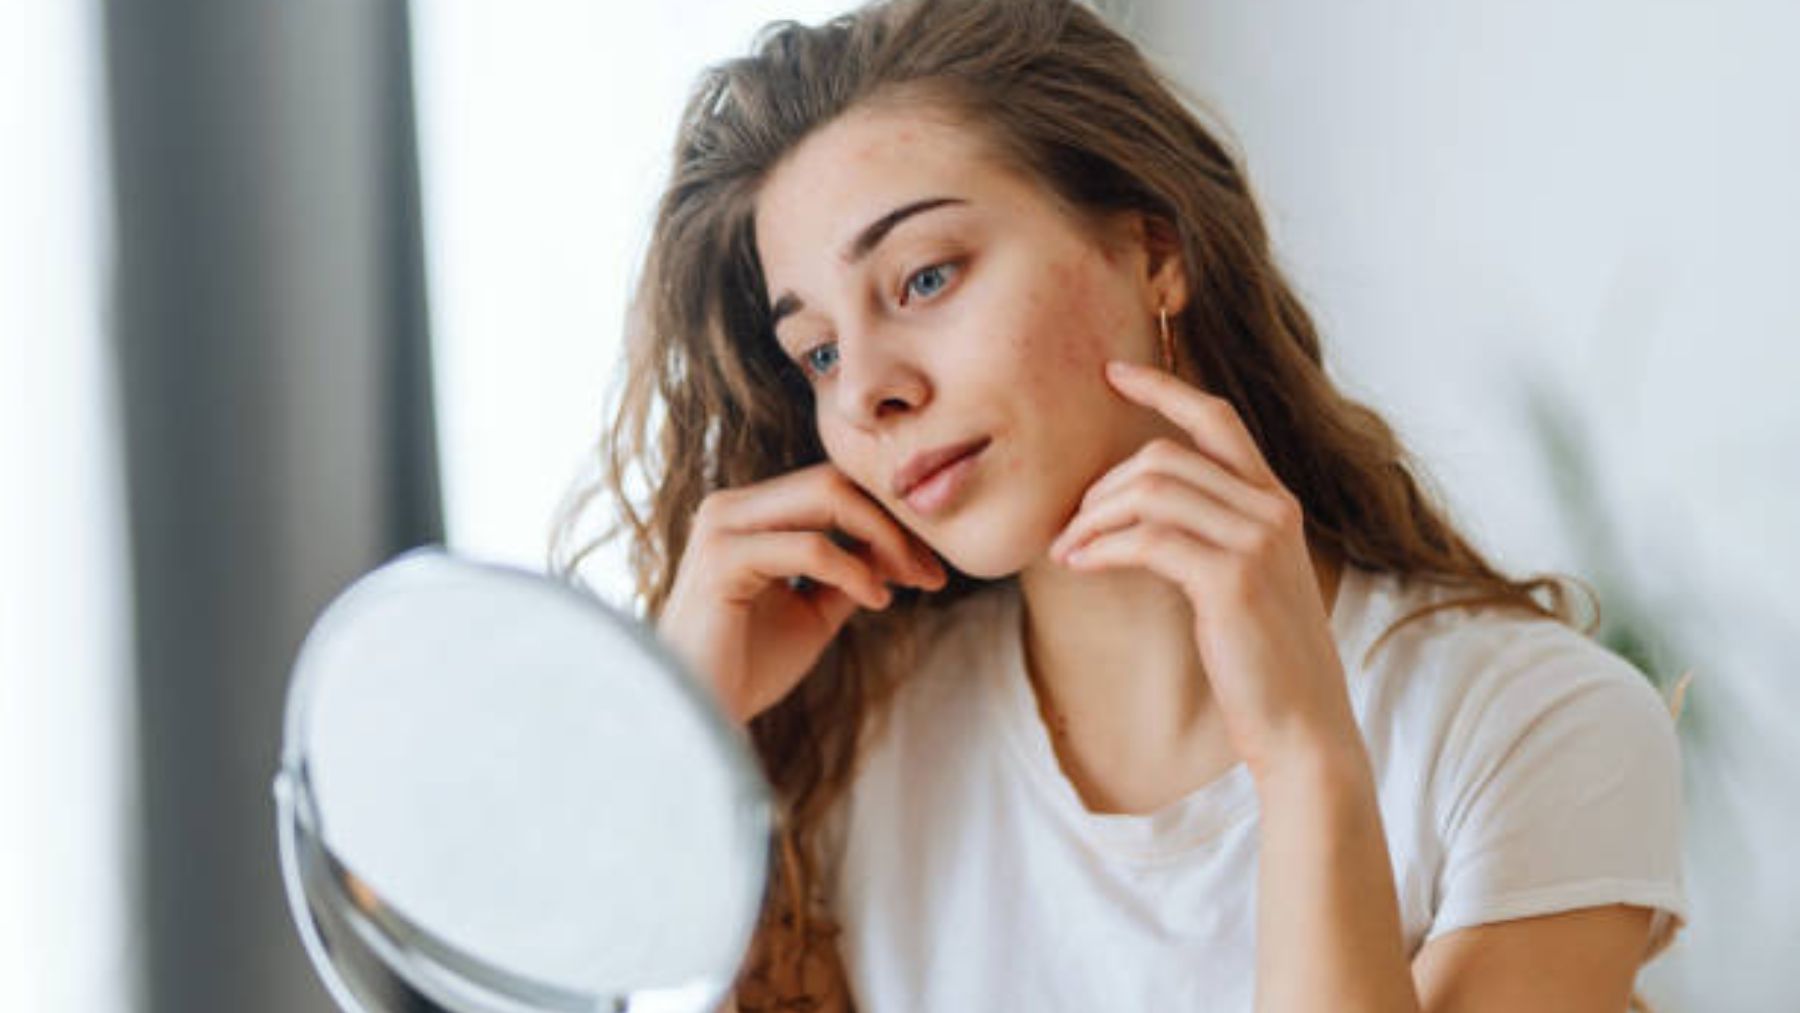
[1129,0,1800,1009]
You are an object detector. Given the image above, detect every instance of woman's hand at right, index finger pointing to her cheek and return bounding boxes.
[1049,362,1361,777]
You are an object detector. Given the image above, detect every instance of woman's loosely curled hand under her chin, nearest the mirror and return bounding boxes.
[657,461,949,725]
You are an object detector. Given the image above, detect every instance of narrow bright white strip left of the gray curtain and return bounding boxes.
[0,2,139,1013]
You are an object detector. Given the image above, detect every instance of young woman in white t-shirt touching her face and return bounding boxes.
[558,0,1687,1011]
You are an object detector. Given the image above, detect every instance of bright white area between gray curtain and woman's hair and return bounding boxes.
[414,0,842,611]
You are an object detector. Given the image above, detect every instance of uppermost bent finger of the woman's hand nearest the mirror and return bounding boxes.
[709,464,943,585]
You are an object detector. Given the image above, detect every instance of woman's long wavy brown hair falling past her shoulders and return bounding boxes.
[551,0,1620,1009]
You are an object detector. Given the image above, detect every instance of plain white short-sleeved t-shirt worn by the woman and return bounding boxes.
[823,567,1688,1013]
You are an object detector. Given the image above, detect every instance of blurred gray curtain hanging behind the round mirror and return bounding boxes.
[104,0,443,1013]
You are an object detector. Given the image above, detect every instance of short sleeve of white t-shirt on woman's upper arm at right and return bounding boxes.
[1426,630,1688,959]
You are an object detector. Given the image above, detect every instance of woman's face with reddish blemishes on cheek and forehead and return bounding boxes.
[756,108,1184,578]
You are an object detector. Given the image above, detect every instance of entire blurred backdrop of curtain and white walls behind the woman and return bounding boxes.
[0,0,1800,1013]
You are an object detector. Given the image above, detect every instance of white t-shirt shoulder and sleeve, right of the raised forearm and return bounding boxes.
[1346,581,1688,952]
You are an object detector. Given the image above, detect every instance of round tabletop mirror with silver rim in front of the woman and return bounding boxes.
[274,549,772,1013]
